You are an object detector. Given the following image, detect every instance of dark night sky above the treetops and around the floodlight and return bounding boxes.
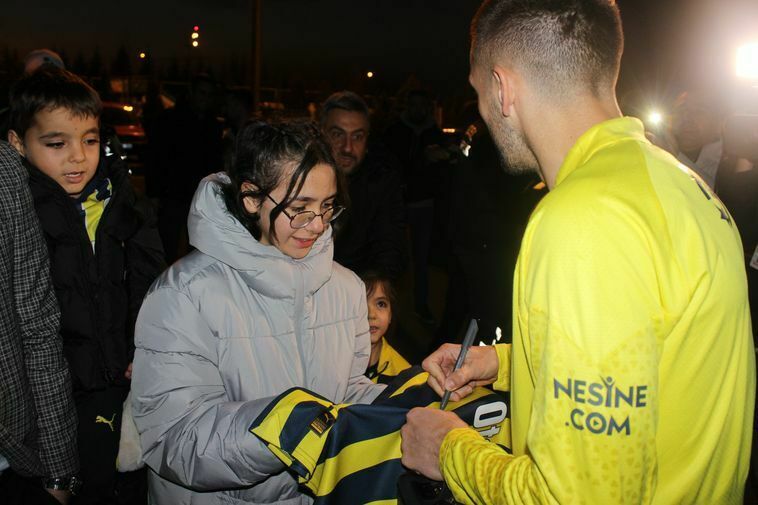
[0,0,758,108]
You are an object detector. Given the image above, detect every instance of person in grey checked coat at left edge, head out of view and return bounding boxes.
[0,141,79,505]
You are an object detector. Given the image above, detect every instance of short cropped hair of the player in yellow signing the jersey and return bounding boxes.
[471,0,624,95]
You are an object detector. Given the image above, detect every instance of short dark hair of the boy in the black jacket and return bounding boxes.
[9,65,103,139]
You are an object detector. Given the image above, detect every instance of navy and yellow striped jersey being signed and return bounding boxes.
[250,366,510,504]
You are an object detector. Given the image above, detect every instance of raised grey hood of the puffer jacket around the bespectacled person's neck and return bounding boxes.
[187,172,334,298]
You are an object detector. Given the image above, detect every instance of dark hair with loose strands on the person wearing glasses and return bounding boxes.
[222,120,348,240]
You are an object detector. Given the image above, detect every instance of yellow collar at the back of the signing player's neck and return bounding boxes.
[555,117,649,186]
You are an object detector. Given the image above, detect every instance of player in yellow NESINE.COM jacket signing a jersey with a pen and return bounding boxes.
[402,0,755,504]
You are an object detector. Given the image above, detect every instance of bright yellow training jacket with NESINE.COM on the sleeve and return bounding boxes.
[440,118,755,505]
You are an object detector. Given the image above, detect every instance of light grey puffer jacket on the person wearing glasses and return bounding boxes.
[132,174,382,505]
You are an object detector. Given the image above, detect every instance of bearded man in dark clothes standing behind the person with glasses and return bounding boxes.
[321,91,406,278]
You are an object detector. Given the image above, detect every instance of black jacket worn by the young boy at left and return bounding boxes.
[26,156,165,391]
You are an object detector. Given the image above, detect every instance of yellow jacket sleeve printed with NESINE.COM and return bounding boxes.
[440,187,667,504]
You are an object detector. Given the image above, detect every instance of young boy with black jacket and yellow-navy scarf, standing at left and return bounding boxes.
[8,68,164,505]
